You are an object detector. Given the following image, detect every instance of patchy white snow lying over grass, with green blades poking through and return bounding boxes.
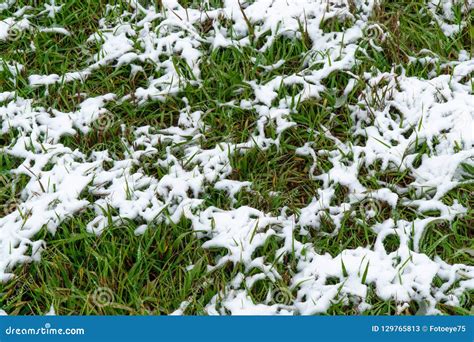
[0,0,474,315]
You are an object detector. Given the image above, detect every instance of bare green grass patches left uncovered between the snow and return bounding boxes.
[0,0,474,315]
